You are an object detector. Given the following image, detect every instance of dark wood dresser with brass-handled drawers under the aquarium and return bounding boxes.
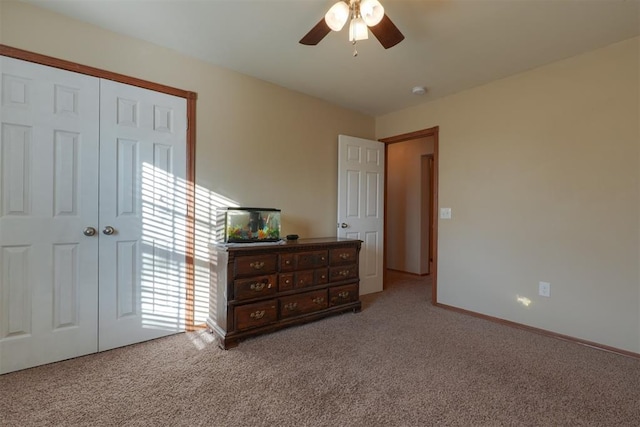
[207,238,362,349]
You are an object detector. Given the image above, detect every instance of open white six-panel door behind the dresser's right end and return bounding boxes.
[338,135,384,294]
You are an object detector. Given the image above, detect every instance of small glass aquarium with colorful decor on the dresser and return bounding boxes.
[216,208,280,243]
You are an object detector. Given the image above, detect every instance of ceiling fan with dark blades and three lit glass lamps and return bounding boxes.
[300,0,404,50]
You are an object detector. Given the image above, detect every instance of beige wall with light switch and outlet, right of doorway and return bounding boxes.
[376,38,640,352]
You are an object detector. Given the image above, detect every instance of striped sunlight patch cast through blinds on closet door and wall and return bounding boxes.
[140,163,238,330]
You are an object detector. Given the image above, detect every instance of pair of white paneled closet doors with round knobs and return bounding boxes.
[0,57,186,374]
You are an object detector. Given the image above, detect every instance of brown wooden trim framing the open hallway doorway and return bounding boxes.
[378,126,440,305]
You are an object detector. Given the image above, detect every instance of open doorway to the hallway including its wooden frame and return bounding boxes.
[380,126,438,305]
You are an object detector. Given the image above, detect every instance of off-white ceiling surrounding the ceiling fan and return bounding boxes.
[22,0,640,115]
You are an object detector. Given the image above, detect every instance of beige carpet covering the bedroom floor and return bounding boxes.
[0,274,640,427]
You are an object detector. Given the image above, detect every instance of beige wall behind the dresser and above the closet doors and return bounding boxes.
[0,0,375,320]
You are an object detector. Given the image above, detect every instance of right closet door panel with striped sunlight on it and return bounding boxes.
[99,80,187,351]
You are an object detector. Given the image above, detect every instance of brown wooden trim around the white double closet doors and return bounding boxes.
[0,44,198,330]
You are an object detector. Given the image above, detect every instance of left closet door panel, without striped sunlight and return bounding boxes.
[0,57,99,374]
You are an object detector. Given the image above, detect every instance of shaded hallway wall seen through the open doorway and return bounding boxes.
[387,137,433,274]
